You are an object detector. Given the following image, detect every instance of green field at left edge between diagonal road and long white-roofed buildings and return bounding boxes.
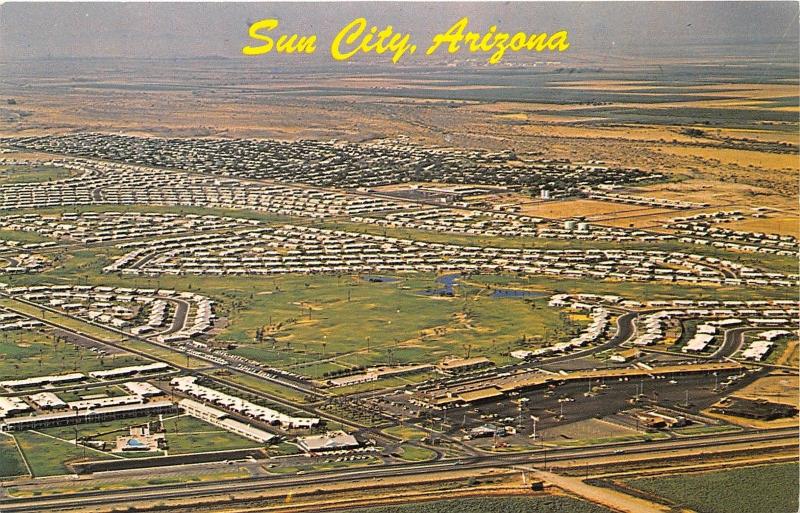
[0,331,147,378]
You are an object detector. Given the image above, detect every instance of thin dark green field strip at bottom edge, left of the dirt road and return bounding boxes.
[330,495,611,513]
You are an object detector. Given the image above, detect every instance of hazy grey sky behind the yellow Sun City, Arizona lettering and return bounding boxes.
[0,2,798,60]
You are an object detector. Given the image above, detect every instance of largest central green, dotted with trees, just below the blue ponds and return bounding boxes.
[221,275,580,374]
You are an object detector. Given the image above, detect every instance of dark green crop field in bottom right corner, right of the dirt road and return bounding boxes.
[625,463,800,513]
